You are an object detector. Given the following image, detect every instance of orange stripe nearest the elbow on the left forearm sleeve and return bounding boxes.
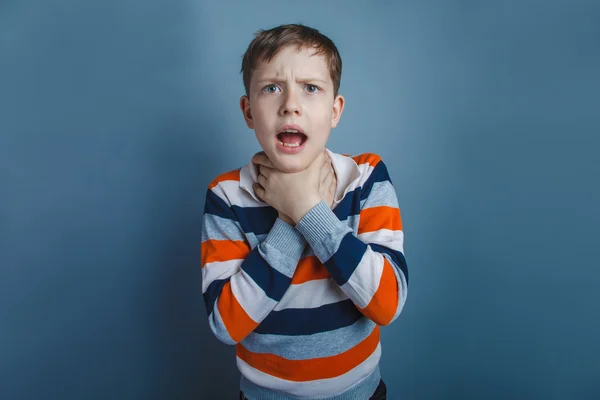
[217,282,258,342]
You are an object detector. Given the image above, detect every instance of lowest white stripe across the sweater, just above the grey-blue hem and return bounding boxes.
[237,343,381,398]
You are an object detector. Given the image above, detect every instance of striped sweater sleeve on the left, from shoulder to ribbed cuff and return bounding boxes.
[201,188,306,344]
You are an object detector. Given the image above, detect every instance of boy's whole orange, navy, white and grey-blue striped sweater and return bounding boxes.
[201,150,408,400]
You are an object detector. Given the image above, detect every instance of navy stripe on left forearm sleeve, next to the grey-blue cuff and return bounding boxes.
[242,246,292,301]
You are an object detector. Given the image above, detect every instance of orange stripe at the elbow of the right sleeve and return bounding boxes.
[360,257,398,325]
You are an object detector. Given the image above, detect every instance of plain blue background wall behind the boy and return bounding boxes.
[0,0,600,399]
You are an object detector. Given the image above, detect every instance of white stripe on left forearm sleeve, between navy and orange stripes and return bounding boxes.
[230,269,277,322]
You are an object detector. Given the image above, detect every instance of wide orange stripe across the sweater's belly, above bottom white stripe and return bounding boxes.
[236,326,379,382]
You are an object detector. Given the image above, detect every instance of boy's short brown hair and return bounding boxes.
[240,24,342,97]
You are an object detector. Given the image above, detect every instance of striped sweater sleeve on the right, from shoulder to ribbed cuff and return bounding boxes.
[296,161,408,325]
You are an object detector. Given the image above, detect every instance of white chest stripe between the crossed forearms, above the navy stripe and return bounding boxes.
[274,278,348,311]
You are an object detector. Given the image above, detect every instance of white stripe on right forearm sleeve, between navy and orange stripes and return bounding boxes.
[342,247,383,308]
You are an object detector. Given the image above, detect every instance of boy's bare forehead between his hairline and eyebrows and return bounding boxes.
[253,45,331,81]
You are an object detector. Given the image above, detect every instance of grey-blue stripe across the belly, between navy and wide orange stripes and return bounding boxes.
[242,318,376,360]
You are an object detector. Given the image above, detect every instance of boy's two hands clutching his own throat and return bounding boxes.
[252,150,335,223]
